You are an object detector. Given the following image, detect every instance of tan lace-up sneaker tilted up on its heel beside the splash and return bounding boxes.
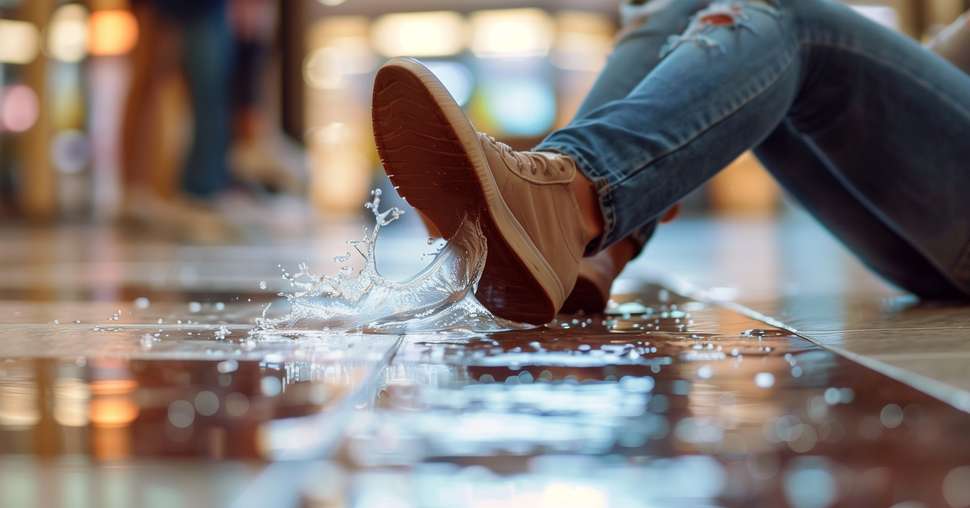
[373,59,592,324]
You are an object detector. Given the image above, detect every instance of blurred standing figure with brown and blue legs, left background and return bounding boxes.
[121,0,232,239]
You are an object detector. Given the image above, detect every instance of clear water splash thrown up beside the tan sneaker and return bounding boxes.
[253,189,522,336]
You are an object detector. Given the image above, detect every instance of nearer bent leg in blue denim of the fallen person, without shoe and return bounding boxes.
[539,0,970,296]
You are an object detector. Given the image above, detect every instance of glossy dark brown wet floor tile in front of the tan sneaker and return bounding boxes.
[306,290,970,507]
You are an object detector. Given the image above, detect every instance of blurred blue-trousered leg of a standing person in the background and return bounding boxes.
[182,2,232,197]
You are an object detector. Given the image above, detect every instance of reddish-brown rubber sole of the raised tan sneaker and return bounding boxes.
[372,59,566,324]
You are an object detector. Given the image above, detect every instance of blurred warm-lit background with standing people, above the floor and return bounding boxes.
[0,0,970,240]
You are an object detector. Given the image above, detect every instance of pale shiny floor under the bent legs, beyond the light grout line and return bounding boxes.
[626,210,970,412]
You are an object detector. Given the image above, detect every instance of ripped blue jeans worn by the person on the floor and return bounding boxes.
[537,0,970,298]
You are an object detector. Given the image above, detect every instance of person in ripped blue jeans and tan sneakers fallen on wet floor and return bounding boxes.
[373,0,970,324]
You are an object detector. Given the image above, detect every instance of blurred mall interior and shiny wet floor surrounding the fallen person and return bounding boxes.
[0,0,970,508]
